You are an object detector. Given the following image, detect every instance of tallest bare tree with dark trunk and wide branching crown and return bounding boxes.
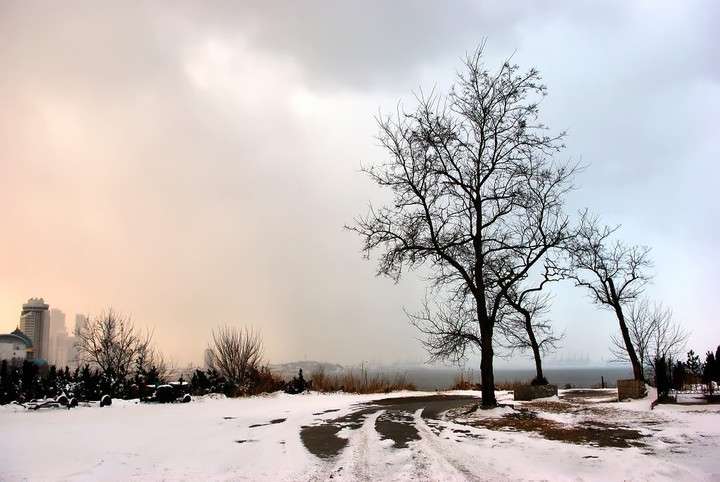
[350,47,575,407]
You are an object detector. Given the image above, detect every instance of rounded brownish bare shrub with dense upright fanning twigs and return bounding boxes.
[208,326,263,392]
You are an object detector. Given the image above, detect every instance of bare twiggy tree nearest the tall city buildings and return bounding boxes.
[76,308,152,380]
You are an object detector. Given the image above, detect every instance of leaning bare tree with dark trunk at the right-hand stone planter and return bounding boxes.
[567,211,652,380]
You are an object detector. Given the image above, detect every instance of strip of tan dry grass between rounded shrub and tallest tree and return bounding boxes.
[310,367,416,393]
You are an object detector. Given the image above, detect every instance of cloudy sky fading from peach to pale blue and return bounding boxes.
[0,0,720,366]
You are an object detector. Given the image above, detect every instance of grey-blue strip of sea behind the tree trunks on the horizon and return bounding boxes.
[383,366,633,390]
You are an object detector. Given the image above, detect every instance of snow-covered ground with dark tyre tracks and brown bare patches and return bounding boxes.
[0,390,720,481]
